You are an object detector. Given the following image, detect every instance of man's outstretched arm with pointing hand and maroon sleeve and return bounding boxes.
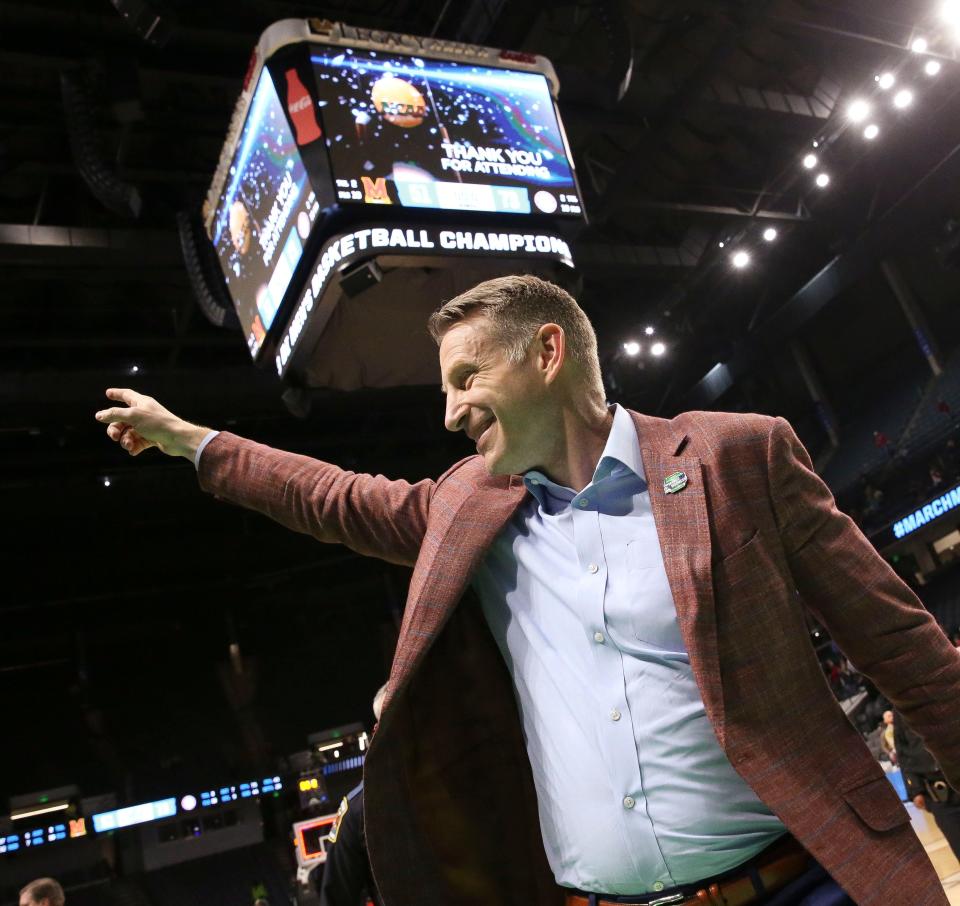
[97,389,434,565]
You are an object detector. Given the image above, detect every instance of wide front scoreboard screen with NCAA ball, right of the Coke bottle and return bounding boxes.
[310,47,582,217]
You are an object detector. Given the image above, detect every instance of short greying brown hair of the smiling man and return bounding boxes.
[427,274,603,397]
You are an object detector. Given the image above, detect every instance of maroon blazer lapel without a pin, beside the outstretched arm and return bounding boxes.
[390,475,527,697]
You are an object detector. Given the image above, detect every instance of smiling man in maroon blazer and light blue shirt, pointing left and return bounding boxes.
[97,276,960,906]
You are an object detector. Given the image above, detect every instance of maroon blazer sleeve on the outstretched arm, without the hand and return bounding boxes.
[197,431,435,566]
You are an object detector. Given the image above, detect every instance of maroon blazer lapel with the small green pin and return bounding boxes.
[631,412,724,745]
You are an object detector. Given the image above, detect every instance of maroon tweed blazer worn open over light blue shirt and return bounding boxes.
[199,412,960,906]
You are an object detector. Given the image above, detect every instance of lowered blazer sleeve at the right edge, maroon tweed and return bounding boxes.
[767,418,960,789]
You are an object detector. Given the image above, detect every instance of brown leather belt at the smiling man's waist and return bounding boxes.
[566,834,812,906]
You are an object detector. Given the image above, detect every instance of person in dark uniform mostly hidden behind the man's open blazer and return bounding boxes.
[320,684,387,906]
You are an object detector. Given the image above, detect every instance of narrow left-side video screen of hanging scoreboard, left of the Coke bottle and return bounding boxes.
[212,69,319,357]
